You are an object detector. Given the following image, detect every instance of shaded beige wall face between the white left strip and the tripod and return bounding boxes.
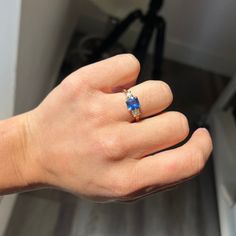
[15,0,77,113]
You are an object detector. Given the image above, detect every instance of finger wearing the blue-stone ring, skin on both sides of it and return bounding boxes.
[107,80,173,122]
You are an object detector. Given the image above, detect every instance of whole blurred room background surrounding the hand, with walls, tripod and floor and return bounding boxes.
[0,0,236,236]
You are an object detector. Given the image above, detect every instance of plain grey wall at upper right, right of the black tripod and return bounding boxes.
[163,0,236,75]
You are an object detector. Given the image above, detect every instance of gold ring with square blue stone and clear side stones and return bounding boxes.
[123,89,141,121]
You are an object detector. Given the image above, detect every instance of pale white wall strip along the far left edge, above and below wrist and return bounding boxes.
[0,0,21,236]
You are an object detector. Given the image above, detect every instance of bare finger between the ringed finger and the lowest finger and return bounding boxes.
[123,112,189,158]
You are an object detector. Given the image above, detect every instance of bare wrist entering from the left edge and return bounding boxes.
[0,113,43,194]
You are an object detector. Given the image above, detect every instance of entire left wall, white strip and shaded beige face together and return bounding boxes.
[0,0,77,236]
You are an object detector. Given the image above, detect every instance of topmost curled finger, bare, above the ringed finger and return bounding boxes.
[70,54,140,93]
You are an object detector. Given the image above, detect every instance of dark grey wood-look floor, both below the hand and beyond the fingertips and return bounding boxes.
[5,58,227,236]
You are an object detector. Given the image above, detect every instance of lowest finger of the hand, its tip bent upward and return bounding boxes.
[131,129,212,189]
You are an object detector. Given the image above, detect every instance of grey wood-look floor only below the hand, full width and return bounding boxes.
[5,163,220,236]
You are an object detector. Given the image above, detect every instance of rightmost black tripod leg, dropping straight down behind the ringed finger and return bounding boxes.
[153,17,166,79]
